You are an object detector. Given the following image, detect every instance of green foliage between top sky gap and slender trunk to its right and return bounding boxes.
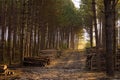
[80,0,93,33]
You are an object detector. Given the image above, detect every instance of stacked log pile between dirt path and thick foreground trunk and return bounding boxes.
[86,47,105,71]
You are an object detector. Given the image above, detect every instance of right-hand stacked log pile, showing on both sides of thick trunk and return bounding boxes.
[86,48,120,71]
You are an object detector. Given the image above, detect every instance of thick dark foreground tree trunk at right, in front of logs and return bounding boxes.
[104,0,114,76]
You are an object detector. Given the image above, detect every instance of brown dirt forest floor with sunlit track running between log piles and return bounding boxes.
[0,52,120,80]
